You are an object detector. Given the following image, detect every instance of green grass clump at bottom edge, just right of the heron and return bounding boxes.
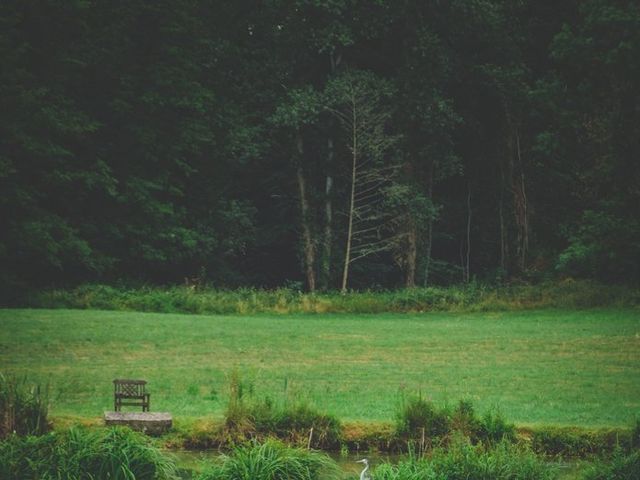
[373,438,555,480]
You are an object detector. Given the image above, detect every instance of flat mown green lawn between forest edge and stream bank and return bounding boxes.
[0,309,640,426]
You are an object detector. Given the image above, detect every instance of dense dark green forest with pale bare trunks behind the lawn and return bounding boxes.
[0,0,640,293]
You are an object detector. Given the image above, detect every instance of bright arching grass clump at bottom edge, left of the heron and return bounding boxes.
[198,440,339,480]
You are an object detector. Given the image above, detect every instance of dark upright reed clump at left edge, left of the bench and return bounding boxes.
[0,373,49,439]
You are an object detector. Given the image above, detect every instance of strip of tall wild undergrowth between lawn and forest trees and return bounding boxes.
[19,280,640,315]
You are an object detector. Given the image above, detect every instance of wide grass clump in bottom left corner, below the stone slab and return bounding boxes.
[0,428,178,480]
